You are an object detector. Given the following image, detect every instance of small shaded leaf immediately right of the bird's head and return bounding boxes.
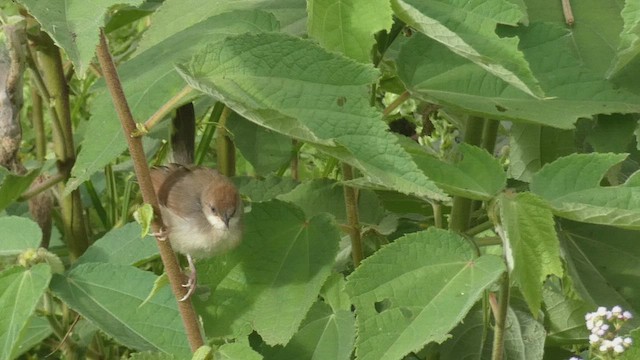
[233,174,298,202]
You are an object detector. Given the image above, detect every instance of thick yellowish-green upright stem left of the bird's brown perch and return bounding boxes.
[39,33,89,259]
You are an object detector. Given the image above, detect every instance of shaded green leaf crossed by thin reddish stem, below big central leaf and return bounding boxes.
[277,179,384,225]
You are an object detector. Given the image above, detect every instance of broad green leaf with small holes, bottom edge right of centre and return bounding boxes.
[347,228,505,360]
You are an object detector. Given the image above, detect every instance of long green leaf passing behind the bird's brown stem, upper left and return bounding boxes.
[65,11,277,193]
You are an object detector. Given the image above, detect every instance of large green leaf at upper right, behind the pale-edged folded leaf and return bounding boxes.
[397,23,640,129]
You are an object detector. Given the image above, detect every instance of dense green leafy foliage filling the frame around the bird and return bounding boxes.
[0,0,640,360]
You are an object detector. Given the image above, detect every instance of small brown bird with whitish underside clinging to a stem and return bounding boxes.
[151,164,244,301]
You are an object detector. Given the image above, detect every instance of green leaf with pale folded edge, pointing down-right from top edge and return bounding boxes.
[391,0,544,97]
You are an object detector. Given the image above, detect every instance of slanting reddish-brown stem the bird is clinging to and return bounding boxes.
[97,31,204,352]
